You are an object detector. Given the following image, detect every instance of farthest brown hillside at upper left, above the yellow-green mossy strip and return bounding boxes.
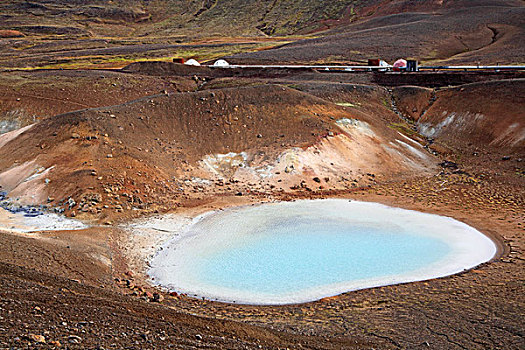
[0,0,366,37]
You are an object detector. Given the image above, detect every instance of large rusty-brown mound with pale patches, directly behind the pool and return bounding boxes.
[0,85,436,217]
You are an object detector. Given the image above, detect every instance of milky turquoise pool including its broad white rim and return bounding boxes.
[149,199,496,304]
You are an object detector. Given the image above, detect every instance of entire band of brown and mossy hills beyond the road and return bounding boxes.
[0,0,525,68]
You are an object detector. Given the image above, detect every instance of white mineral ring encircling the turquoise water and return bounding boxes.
[146,199,497,305]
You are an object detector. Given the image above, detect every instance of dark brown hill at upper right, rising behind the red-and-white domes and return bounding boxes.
[233,1,525,64]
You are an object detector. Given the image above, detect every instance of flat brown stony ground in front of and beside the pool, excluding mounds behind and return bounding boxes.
[0,166,525,349]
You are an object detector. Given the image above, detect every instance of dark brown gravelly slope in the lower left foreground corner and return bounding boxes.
[0,237,360,349]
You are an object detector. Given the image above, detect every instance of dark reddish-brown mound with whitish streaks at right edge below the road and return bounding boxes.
[395,79,525,155]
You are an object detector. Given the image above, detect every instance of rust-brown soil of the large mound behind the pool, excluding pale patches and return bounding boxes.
[0,72,438,220]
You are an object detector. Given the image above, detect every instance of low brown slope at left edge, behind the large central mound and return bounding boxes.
[0,71,198,134]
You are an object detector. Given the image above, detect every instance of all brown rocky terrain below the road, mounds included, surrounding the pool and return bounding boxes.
[0,63,525,349]
